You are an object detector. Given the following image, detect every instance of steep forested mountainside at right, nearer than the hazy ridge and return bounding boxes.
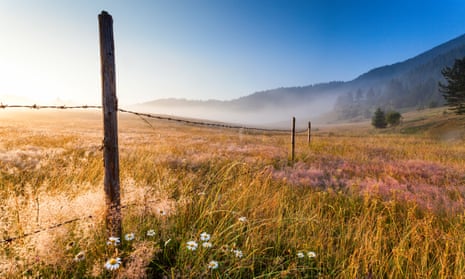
[335,35,465,119]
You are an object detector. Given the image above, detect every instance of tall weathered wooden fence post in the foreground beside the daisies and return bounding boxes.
[98,11,122,237]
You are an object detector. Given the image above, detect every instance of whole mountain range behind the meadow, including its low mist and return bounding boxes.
[138,35,465,125]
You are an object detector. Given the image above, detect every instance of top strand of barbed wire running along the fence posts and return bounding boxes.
[0,104,307,133]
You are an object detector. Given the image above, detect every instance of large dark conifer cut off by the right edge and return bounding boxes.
[439,57,465,114]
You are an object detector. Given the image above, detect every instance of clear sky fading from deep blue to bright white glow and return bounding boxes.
[0,0,465,106]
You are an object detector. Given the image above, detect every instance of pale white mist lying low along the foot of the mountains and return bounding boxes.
[133,94,337,129]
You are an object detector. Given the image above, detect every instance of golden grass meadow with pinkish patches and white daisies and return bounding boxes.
[0,110,465,278]
